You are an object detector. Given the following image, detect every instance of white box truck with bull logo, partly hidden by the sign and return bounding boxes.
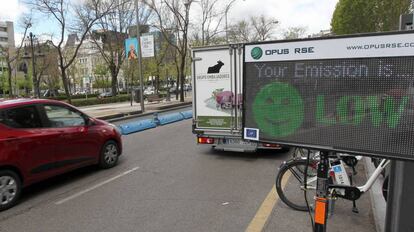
[191,44,282,152]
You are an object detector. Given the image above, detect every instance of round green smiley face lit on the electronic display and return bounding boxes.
[253,82,304,137]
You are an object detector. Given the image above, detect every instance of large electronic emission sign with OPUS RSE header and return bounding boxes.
[243,30,414,160]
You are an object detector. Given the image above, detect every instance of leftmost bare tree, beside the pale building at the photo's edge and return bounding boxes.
[0,16,32,98]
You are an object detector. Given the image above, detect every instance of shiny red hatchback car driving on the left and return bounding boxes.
[0,99,122,211]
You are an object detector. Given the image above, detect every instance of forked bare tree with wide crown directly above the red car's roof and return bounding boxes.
[28,0,114,103]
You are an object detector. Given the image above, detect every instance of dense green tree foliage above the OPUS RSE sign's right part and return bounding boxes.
[331,0,410,35]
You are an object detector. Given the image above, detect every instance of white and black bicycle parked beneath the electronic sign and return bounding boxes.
[276,154,390,213]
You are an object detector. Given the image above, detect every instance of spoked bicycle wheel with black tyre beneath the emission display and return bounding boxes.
[276,160,317,211]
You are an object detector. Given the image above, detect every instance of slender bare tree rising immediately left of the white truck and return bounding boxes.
[145,0,194,102]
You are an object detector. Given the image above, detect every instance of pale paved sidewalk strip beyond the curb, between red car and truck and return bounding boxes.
[79,96,192,120]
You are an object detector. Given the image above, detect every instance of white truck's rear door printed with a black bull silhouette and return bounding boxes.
[192,46,242,134]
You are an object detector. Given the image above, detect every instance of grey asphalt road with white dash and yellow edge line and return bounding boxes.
[0,112,375,232]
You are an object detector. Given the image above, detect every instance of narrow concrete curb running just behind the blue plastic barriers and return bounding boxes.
[96,102,193,122]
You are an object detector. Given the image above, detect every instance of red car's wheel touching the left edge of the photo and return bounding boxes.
[0,170,22,211]
